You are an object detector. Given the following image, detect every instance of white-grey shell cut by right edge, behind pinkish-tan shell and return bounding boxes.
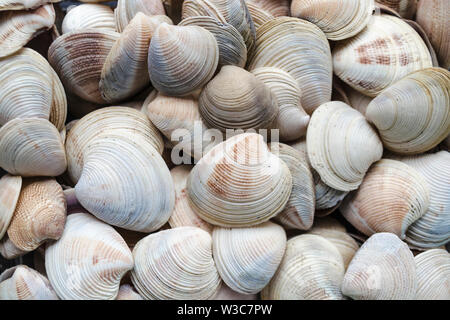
[398,151,450,248]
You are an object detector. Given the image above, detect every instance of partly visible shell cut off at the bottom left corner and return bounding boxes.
[0,265,59,300]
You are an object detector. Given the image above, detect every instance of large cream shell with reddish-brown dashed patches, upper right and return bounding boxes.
[333,14,432,97]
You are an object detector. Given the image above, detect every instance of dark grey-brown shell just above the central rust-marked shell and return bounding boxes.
[199,66,278,132]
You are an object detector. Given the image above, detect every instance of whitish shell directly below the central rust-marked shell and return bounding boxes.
[212,222,286,294]
